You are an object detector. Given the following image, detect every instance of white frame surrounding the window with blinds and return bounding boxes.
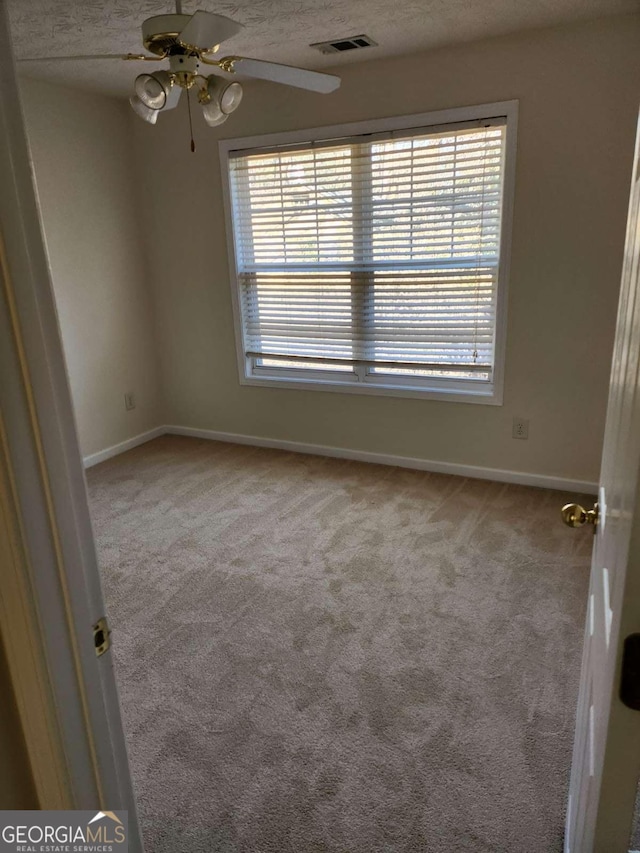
[219,100,518,406]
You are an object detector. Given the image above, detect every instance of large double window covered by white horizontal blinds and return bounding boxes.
[222,104,514,402]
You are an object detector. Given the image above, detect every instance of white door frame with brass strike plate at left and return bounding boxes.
[0,0,142,840]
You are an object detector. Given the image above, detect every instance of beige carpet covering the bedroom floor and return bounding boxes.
[88,436,592,853]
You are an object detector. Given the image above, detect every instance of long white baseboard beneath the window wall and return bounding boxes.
[163,426,598,494]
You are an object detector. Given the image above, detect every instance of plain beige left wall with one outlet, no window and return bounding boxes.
[21,80,161,455]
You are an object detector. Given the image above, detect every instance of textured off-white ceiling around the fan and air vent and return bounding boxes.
[8,0,639,94]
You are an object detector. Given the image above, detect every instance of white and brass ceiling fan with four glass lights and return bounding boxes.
[22,0,340,151]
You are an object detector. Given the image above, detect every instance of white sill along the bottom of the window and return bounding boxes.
[240,372,502,406]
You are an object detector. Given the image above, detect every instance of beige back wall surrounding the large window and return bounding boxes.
[132,16,640,481]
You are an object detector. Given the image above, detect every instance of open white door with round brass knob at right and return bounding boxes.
[565,110,640,853]
